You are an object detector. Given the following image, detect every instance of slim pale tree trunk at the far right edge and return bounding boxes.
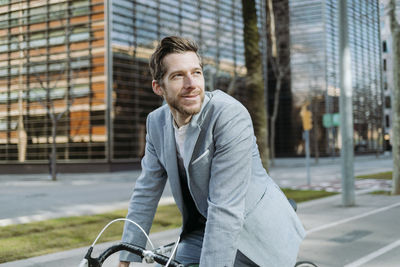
[388,0,400,195]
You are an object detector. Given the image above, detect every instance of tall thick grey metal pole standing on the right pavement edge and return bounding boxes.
[338,0,355,206]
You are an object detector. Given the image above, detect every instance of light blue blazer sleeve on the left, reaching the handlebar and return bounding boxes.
[120,115,167,261]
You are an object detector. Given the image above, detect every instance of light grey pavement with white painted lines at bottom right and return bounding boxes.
[298,194,400,267]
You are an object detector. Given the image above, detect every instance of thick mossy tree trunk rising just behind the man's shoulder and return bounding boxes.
[242,0,269,169]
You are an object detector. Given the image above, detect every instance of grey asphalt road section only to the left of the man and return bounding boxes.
[0,171,171,226]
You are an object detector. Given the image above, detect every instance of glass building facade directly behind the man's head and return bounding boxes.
[111,0,245,162]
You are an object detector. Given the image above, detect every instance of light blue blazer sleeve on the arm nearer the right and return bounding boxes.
[200,102,254,267]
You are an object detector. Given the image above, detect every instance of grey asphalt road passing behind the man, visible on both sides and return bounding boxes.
[0,156,392,226]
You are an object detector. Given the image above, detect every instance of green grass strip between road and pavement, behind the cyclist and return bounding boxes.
[0,189,335,263]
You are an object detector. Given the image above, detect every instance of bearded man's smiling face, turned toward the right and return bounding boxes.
[153,52,204,119]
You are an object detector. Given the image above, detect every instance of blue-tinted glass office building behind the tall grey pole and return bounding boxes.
[290,0,383,155]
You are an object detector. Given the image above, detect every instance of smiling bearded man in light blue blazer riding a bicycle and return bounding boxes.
[119,36,304,267]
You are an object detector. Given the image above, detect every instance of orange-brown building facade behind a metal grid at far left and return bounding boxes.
[0,1,107,168]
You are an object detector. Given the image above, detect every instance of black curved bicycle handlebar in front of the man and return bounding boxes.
[79,242,184,267]
